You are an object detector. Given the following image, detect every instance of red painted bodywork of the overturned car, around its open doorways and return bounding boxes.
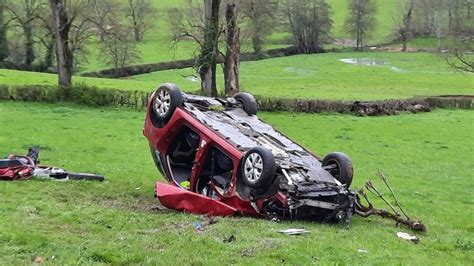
[143,100,268,216]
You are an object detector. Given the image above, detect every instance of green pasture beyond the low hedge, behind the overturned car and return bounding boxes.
[0,52,474,100]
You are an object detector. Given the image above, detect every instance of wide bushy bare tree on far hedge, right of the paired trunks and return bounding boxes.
[286,0,332,53]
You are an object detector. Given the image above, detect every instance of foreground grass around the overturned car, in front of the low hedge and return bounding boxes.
[0,102,474,265]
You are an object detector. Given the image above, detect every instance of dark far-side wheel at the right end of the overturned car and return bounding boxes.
[322,152,354,188]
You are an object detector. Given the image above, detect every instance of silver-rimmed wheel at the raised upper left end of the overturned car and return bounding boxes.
[153,83,183,124]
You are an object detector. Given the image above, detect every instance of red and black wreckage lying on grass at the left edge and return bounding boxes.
[0,147,104,181]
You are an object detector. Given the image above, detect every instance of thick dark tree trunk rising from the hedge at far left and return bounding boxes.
[49,0,74,87]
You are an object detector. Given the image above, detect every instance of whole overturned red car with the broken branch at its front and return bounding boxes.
[143,83,426,231]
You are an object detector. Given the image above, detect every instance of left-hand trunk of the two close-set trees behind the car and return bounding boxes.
[199,0,220,96]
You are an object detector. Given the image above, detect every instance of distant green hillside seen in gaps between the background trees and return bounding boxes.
[85,0,401,71]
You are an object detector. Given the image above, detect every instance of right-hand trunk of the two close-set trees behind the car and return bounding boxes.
[224,3,240,95]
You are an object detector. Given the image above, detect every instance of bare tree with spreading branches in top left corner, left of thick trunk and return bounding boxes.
[4,0,46,66]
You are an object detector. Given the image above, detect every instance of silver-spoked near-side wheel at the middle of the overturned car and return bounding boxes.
[240,147,276,190]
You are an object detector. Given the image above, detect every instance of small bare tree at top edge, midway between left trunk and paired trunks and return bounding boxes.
[126,0,157,42]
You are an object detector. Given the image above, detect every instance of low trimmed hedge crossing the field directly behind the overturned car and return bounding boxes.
[0,84,474,116]
